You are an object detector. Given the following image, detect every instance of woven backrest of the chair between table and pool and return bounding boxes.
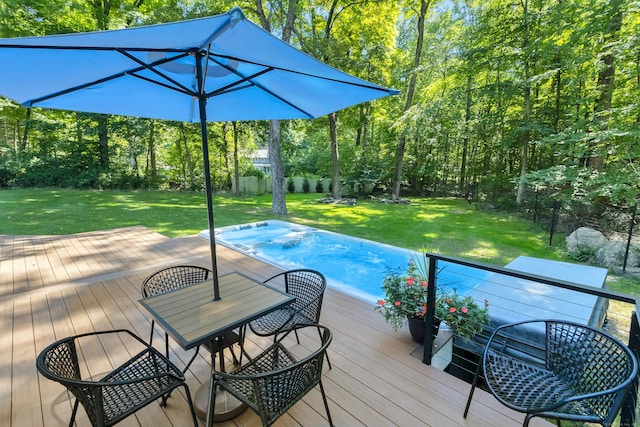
[265,269,327,323]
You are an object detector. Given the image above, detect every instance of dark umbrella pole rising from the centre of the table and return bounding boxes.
[196,58,220,301]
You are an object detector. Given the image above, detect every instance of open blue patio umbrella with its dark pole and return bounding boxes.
[0,8,398,299]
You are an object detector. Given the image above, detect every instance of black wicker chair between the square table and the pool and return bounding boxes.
[249,269,331,369]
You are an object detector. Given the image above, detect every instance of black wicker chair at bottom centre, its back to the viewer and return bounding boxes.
[213,325,333,426]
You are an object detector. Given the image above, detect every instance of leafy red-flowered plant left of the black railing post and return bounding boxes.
[375,255,445,330]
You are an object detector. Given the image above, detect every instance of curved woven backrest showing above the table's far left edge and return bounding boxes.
[142,265,211,298]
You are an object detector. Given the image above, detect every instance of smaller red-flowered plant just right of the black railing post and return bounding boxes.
[439,291,489,341]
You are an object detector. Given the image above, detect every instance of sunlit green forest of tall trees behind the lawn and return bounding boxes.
[0,0,640,232]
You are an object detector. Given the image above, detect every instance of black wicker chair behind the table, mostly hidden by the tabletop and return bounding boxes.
[142,265,241,372]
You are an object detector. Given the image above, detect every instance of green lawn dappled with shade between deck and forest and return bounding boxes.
[0,189,568,265]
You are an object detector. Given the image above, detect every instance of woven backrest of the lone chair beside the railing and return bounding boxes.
[546,321,637,419]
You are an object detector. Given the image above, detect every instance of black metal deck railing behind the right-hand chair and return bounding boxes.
[422,253,640,425]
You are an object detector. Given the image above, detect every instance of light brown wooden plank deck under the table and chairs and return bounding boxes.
[0,227,548,427]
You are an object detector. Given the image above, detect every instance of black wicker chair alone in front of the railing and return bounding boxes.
[464,320,638,426]
